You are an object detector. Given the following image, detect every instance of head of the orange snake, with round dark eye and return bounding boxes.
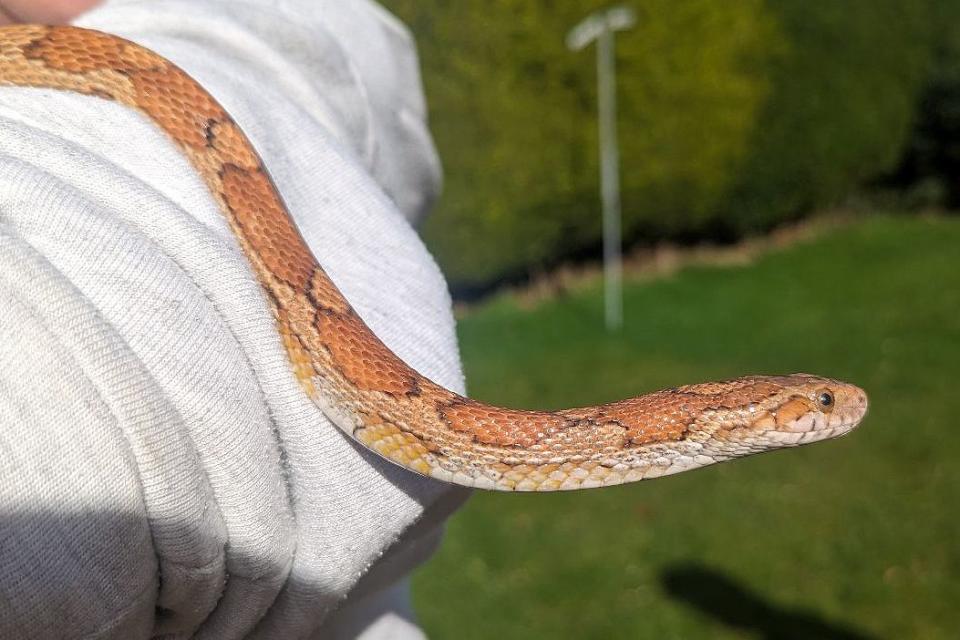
[741,373,867,449]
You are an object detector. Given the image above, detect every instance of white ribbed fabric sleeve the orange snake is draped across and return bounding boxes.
[0,0,463,638]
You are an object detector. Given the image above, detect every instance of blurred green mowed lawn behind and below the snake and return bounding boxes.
[414,217,960,640]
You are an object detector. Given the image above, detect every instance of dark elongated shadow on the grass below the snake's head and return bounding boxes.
[660,564,875,640]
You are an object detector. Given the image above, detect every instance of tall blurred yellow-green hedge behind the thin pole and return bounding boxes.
[384,0,929,292]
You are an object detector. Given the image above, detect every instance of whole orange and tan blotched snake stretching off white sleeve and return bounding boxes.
[0,25,867,491]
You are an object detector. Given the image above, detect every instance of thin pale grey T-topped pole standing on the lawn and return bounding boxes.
[567,7,636,331]
